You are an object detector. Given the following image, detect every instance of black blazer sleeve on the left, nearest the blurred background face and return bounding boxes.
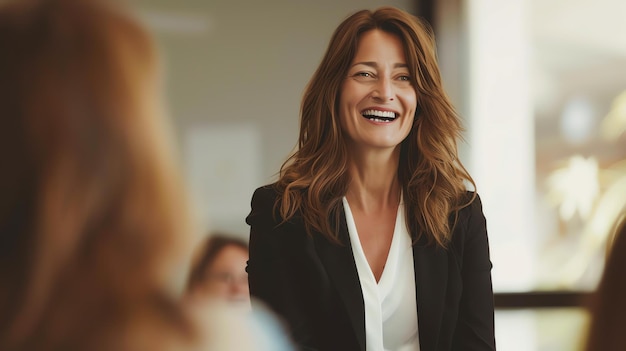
[246,186,317,350]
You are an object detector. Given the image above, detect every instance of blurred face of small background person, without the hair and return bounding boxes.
[196,245,250,305]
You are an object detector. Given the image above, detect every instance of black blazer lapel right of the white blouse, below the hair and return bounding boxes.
[413,240,448,351]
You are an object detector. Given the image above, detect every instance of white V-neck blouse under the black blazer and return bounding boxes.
[343,197,420,351]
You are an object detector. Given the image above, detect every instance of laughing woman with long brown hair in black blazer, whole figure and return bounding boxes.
[246,7,495,351]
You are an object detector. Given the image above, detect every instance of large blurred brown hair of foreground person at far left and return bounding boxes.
[0,0,189,349]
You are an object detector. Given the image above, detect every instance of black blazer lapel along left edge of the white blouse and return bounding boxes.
[315,206,365,351]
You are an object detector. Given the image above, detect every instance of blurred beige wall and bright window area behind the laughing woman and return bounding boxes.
[129,0,626,351]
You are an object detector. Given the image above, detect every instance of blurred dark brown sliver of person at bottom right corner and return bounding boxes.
[585,214,626,351]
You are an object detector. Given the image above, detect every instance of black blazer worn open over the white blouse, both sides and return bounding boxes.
[246,185,495,351]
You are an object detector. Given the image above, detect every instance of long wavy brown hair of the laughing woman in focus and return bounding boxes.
[275,7,475,247]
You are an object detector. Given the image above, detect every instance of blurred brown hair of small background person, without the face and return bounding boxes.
[187,232,248,291]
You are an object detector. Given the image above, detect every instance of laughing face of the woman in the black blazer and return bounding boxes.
[339,29,417,153]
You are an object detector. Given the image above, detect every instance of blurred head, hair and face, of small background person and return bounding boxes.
[188,233,250,308]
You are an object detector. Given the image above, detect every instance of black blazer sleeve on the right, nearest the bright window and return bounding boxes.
[453,195,496,351]
